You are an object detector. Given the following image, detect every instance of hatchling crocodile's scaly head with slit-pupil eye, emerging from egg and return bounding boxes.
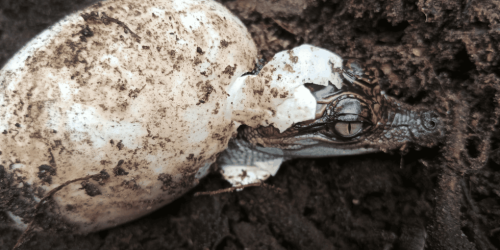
[239,61,444,157]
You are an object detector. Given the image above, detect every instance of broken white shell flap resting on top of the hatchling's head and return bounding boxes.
[228,44,342,132]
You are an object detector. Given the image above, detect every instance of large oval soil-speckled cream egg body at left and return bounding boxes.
[0,0,257,233]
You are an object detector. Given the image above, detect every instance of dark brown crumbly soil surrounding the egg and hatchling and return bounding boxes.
[0,0,500,250]
